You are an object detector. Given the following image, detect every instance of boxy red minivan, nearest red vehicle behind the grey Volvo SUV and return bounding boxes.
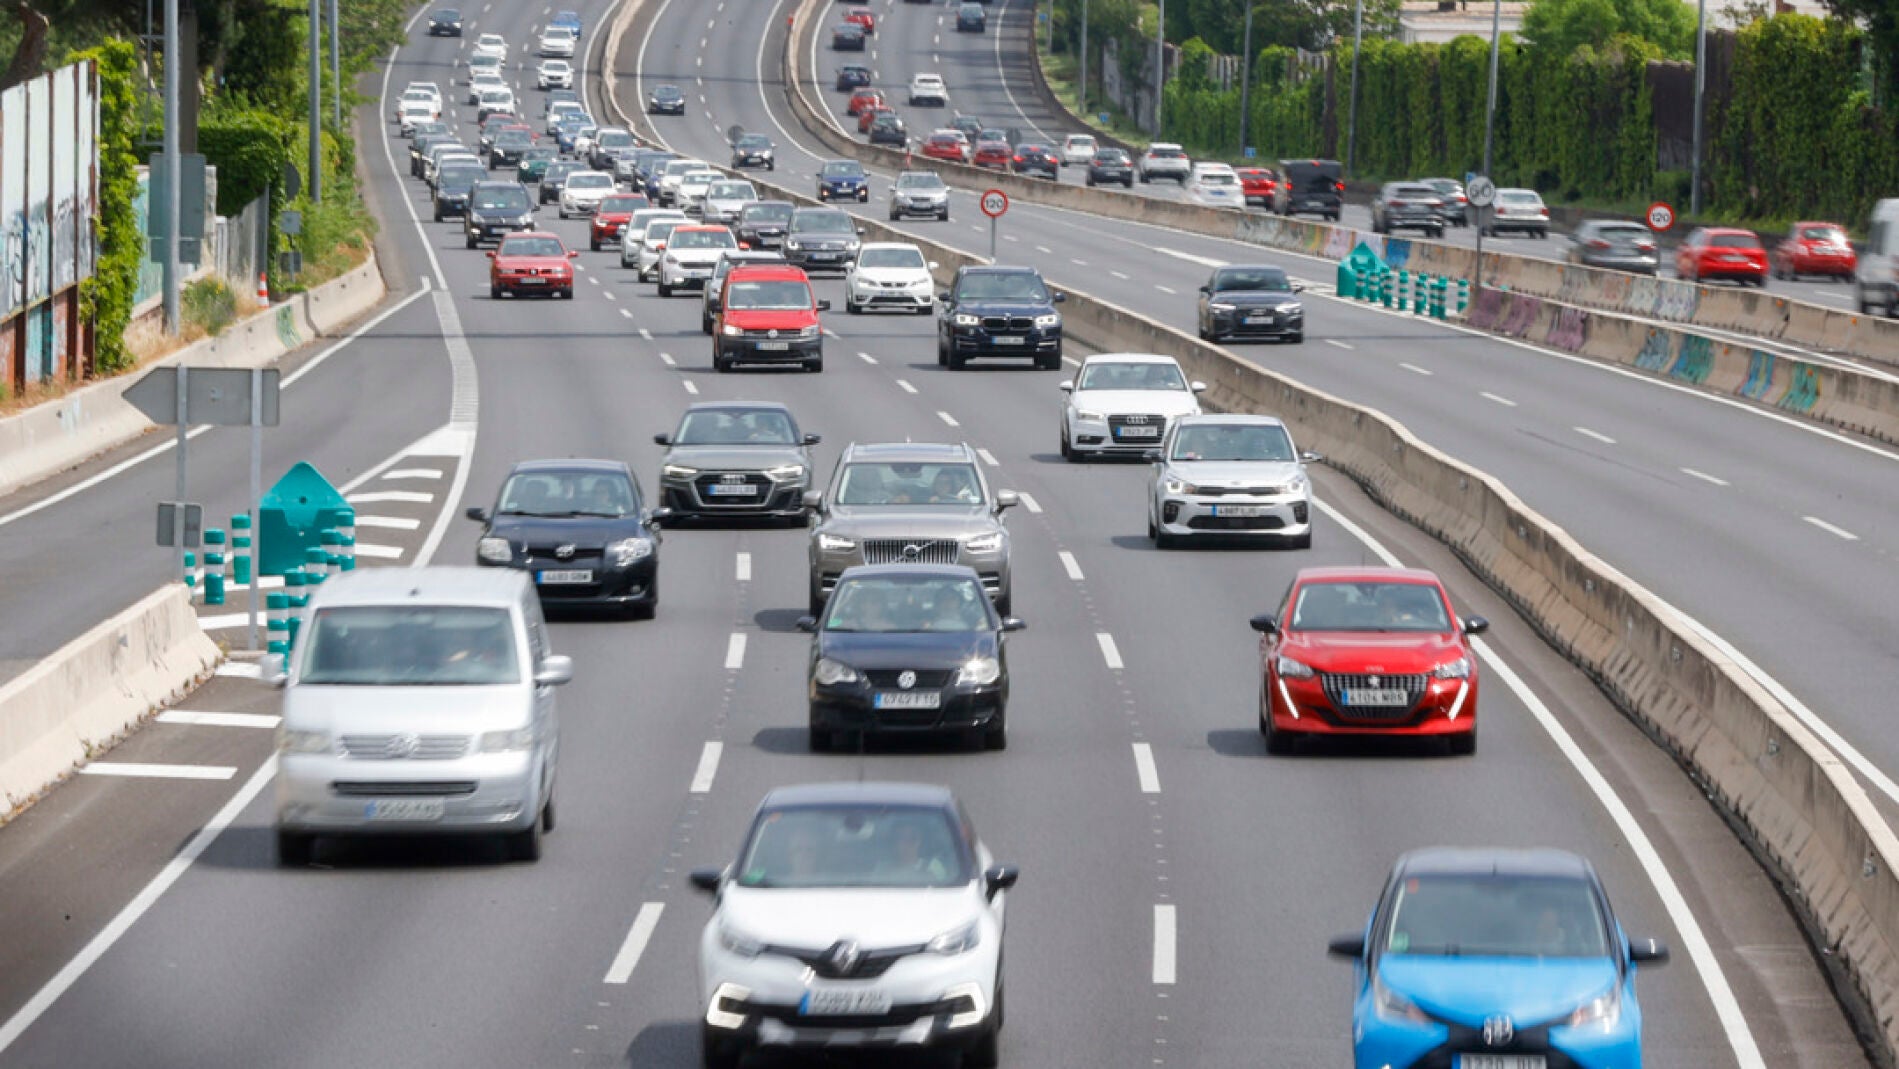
[712,264,830,372]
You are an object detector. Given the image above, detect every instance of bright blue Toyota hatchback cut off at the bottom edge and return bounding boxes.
[1329,847,1667,1069]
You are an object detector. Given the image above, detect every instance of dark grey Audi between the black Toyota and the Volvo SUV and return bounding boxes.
[653,401,818,522]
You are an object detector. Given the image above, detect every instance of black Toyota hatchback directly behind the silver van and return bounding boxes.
[467,459,670,619]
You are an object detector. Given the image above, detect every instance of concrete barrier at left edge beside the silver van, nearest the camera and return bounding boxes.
[0,583,222,822]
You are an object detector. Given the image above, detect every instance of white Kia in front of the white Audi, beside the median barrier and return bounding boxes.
[1147,416,1318,549]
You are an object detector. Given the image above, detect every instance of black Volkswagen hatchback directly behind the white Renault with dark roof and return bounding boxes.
[798,564,1024,752]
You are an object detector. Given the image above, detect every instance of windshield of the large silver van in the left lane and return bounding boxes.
[298,606,520,687]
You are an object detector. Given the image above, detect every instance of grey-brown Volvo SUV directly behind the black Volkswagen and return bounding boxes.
[805,442,1016,615]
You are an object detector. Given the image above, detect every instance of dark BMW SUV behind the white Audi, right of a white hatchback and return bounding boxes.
[936,266,1065,370]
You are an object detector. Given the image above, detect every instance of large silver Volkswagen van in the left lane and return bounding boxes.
[266,568,573,866]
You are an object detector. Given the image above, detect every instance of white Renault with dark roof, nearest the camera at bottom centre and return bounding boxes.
[691,782,1018,1069]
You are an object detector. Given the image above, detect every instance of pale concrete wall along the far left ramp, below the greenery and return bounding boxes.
[0,256,387,496]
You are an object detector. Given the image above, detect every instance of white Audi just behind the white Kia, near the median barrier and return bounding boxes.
[1062,353,1206,461]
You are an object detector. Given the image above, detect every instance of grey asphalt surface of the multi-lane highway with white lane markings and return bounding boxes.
[0,0,1891,1069]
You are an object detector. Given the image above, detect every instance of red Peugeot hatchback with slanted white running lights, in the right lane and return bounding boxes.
[1253,568,1489,754]
